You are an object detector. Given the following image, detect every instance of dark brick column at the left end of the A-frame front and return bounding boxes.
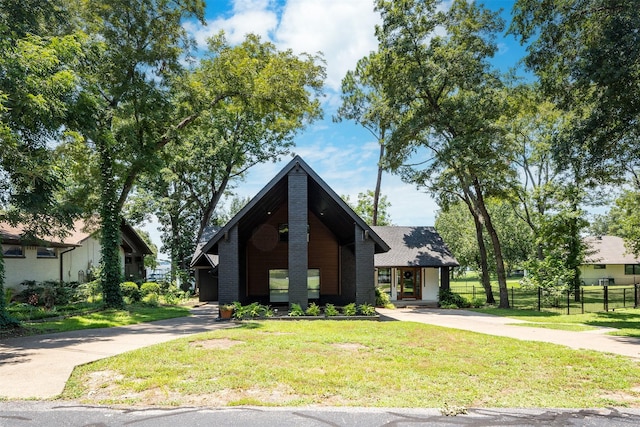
[218,226,240,305]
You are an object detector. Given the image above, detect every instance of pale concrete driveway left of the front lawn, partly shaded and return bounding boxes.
[0,305,230,399]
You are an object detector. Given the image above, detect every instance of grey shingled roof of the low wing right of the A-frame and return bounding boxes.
[371,226,460,267]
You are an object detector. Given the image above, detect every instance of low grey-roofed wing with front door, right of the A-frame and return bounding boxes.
[372,226,460,304]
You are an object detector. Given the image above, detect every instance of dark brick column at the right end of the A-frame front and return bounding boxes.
[354,224,376,305]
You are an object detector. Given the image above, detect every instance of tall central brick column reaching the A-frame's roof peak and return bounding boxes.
[288,165,309,309]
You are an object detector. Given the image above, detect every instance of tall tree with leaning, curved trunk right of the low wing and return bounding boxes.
[376,0,512,307]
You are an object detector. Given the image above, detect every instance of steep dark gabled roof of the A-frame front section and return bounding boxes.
[202,156,389,253]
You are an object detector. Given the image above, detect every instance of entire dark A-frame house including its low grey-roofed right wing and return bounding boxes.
[191,156,458,307]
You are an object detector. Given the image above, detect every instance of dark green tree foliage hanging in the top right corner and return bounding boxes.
[511,0,640,173]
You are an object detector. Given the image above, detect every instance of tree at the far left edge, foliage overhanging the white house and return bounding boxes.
[0,0,82,327]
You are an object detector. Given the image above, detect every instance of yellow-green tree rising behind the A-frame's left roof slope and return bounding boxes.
[137,33,325,282]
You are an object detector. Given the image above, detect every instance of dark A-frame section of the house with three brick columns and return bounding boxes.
[192,156,389,307]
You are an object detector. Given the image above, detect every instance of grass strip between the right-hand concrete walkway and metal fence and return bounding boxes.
[474,308,640,338]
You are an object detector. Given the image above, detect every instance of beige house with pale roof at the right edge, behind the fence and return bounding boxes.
[580,236,640,285]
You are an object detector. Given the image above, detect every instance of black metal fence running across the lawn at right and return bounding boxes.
[451,283,640,314]
